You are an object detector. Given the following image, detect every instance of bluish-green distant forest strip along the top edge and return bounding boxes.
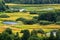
[4,0,60,4]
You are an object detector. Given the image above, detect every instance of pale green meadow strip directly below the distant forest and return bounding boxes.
[6,4,60,11]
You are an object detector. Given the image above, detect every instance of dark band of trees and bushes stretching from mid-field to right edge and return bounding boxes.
[16,9,60,25]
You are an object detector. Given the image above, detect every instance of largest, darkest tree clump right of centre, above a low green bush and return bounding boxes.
[38,12,57,22]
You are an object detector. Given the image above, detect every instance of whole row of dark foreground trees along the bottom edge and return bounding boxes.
[0,28,60,40]
